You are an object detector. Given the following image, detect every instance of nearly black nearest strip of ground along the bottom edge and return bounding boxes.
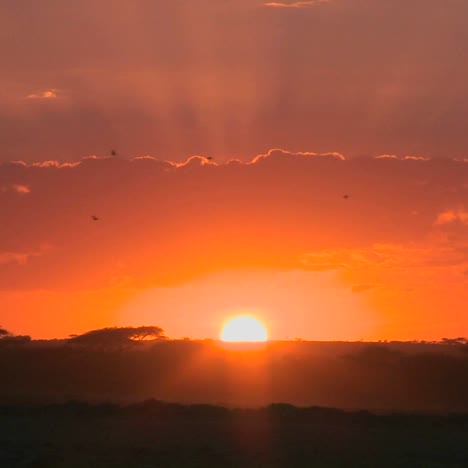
[0,400,468,468]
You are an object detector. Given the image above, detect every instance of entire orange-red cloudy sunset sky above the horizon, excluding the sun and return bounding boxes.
[0,0,468,340]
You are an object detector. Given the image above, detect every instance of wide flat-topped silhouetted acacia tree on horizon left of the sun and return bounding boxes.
[68,326,165,349]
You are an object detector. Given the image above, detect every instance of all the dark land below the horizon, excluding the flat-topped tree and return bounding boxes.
[0,337,468,468]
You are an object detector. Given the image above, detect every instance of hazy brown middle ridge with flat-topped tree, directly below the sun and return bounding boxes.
[0,334,468,413]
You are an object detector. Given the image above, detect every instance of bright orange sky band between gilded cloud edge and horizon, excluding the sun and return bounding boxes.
[0,154,468,339]
